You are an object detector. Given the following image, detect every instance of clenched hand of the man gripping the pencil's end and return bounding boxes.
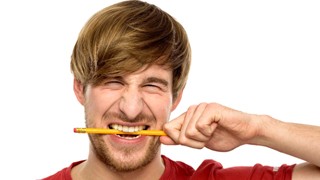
[160,103,259,151]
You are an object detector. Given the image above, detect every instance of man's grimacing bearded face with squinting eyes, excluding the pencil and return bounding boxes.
[78,65,173,171]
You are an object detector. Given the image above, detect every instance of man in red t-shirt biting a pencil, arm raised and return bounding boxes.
[45,1,320,180]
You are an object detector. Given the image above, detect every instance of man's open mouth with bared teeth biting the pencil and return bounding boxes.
[108,124,149,139]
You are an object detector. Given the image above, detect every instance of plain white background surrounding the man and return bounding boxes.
[0,0,320,180]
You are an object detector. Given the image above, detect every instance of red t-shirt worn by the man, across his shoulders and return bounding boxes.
[43,155,294,180]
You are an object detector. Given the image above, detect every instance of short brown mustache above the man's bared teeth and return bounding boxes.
[102,112,156,122]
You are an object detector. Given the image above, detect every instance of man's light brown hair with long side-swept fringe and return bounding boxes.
[71,0,191,98]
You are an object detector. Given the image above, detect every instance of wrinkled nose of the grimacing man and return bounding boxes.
[119,88,144,120]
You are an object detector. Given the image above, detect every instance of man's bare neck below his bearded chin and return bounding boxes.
[71,150,165,180]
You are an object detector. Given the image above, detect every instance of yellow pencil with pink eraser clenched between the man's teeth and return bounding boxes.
[73,128,166,136]
